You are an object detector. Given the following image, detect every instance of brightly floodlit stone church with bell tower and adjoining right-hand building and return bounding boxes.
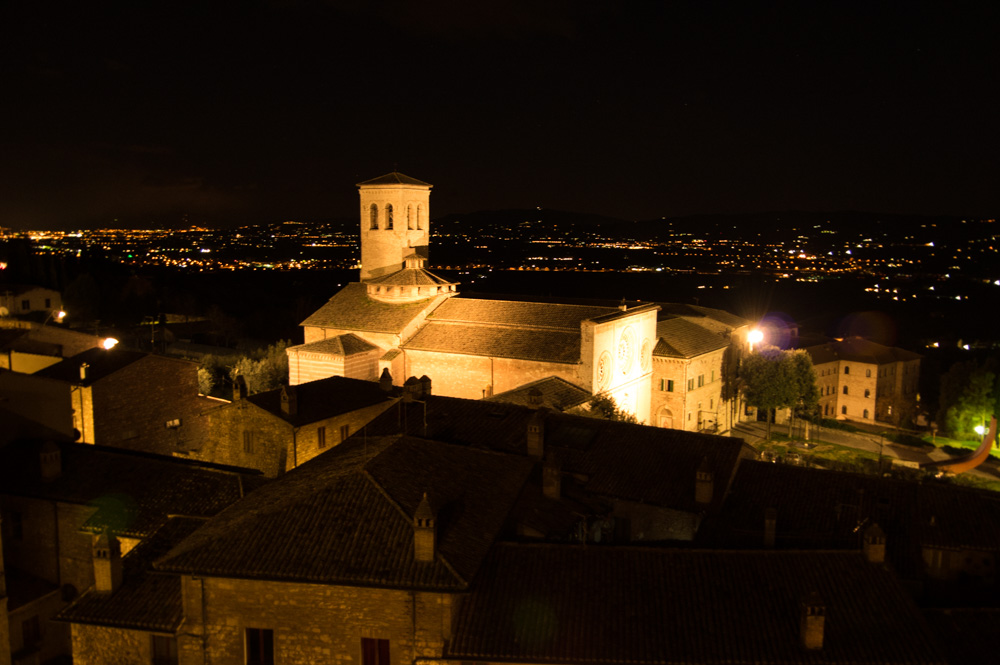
[287,172,749,432]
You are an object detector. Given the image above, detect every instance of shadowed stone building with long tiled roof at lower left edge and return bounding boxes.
[0,440,261,663]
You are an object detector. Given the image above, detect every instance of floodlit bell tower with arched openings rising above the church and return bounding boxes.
[358,171,431,281]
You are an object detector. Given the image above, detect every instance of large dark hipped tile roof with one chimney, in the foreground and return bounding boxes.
[156,436,531,590]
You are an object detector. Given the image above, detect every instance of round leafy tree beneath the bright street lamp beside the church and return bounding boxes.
[740,346,819,439]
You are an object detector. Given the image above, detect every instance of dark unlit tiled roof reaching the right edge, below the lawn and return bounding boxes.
[699,462,1000,579]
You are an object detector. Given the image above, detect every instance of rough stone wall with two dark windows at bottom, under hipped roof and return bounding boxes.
[178,576,452,665]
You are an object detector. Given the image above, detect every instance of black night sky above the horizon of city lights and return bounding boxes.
[0,0,1000,228]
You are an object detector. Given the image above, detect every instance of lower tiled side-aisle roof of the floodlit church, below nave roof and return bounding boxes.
[403,321,580,363]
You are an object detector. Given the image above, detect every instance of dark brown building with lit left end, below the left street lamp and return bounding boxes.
[37,347,218,455]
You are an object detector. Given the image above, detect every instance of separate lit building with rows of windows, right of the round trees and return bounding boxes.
[802,337,921,427]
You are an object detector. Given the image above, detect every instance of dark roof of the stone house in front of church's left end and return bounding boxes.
[244,376,393,427]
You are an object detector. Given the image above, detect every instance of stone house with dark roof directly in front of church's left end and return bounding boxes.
[189,376,399,477]
